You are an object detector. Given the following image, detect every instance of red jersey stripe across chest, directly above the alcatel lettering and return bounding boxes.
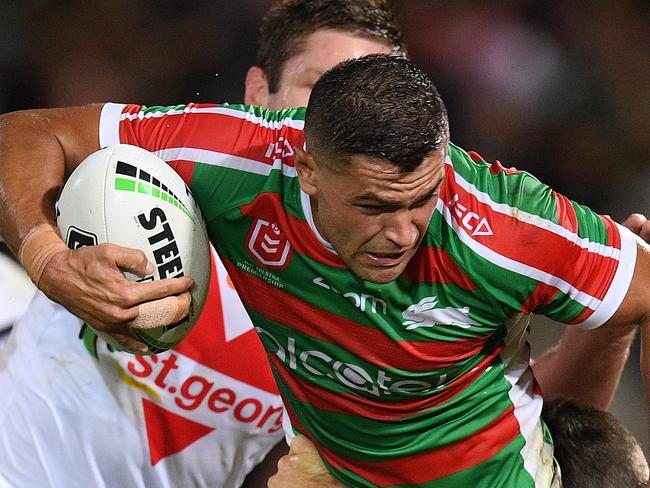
[224,260,489,371]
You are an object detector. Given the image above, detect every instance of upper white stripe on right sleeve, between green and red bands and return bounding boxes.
[454,162,620,259]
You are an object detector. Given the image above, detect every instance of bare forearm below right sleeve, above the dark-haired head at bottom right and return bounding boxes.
[533,325,637,410]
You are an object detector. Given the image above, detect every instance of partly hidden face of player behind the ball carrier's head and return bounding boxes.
[267,30,390,109]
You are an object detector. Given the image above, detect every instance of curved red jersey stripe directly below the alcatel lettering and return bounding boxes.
[271,345,503,421]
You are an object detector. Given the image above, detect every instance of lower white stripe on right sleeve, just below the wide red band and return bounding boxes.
[436,199,601,310]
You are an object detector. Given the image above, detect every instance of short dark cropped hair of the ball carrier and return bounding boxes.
[305,54,449,171]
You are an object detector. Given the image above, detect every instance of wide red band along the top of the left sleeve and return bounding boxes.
[120,103,304,170]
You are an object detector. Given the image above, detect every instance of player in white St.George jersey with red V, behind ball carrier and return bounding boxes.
[0,0,402,487]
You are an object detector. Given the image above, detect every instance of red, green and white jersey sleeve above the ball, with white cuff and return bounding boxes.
[99,103,304,219]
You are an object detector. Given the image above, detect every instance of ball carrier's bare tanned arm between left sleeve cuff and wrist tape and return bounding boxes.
[0,106,100,253]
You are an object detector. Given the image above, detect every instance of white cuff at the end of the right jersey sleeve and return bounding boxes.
[578,224,637,329]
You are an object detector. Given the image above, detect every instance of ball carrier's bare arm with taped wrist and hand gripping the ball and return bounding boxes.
[0,105,192,352]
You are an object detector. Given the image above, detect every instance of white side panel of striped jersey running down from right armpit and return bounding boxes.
[499,314,554,487]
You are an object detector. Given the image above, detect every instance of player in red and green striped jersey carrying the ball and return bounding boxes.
[3,51,650,486]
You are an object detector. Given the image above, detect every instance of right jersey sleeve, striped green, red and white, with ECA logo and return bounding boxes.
[439,146,637,328]
